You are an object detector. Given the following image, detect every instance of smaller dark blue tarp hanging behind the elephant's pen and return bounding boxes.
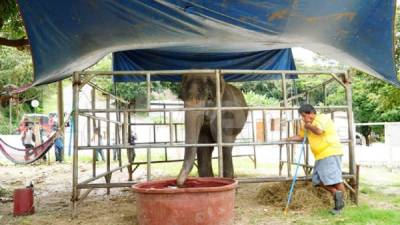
[113,49,296,82]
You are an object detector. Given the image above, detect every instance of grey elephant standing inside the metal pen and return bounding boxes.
[177,74,248,187]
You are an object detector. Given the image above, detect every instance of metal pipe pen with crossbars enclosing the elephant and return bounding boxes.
[72,70,357,215]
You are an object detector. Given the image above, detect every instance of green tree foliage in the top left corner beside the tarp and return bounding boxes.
[0,0,29,50]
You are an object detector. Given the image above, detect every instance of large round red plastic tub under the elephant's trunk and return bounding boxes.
[132,177,237,225]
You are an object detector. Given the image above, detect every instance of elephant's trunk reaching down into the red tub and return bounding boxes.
[176,108,205,187]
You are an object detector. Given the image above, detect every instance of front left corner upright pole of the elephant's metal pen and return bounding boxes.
[72,72,80,217]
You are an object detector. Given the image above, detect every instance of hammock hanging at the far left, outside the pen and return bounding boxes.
[0,132,58,164]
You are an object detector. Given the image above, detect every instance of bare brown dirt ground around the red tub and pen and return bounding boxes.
[0,163,398,225]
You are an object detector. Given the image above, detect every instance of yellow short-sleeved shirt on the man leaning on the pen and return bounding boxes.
[299,114,343,160]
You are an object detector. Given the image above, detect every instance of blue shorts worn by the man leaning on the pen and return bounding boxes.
[312,155,343,186]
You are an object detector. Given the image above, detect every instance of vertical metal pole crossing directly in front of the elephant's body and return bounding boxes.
[215,70,224,177]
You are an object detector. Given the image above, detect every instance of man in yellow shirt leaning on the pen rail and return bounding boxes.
[287,104,345,214]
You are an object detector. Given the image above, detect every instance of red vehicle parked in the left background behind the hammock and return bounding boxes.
[17,113,54,134]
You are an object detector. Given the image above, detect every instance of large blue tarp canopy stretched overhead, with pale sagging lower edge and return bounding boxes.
[18,0,398,85]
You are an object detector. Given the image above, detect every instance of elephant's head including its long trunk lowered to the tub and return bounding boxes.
[177,74,225,186]
